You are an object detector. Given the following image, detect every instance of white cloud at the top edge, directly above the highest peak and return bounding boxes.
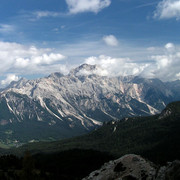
[66,0,111,14]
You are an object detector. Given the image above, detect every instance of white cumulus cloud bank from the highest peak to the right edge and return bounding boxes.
[85,43,180,81]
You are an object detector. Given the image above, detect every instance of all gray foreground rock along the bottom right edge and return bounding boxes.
[83,154,180,180]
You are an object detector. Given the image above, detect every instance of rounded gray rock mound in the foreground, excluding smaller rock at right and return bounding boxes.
[83,154,156,180]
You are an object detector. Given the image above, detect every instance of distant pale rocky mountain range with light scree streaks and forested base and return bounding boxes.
[0,64,180,146]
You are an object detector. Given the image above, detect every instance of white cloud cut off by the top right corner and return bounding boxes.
[154,0,180,20]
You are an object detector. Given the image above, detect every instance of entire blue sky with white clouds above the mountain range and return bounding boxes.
[0,0,180,88]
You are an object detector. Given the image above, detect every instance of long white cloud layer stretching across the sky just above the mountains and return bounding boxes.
[0,42,180,86]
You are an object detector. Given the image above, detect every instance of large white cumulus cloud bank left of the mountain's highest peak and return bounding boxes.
[0,42,65,84]
